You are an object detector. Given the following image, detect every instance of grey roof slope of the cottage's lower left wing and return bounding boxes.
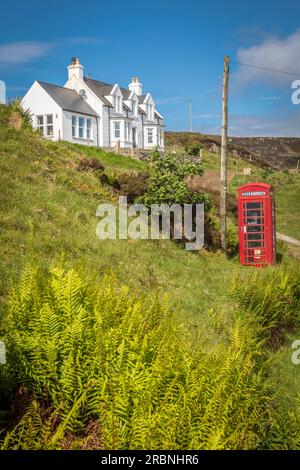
[38,81,96,116]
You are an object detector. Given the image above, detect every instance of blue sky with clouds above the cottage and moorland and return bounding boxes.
[0,0,300,136]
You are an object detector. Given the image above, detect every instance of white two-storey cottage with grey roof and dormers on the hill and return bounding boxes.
[22,58,164,150]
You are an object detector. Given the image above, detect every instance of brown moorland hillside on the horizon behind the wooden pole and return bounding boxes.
[165,132,300,170]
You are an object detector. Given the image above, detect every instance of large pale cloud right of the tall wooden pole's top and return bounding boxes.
[233,30,300,87]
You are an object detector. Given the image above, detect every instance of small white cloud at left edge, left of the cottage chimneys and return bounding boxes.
[0,41,54,64]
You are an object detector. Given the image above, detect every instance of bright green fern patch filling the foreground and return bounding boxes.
[2,267,298,449]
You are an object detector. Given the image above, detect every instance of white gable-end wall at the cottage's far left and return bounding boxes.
[21,82,63,140]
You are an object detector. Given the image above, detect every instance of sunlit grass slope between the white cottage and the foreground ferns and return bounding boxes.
[0,125,241,332]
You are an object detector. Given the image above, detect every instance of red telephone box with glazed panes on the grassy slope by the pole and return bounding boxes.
[238,183,276,266]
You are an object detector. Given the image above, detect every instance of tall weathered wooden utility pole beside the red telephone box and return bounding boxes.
[220,56,229,251]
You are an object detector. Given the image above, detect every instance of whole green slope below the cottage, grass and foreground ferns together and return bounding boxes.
[0,108,300,449]
